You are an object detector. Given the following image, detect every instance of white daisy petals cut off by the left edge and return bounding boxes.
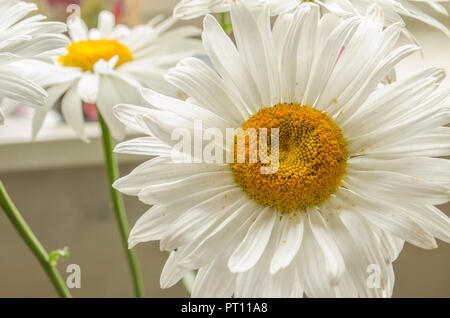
[0,0,69,107]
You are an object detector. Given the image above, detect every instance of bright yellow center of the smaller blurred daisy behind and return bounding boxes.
[58,40,133,72]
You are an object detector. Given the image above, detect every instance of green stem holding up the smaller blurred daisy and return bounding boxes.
[98,111,144,298]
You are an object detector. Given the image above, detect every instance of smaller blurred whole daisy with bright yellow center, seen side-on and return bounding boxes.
[4,11,202,141]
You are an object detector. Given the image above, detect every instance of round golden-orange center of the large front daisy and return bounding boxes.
[231,104,347,212]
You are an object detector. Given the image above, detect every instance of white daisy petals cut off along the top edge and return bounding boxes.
[174,0,450,36]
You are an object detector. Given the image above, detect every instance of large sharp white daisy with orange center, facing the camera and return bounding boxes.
[114,2,450,297]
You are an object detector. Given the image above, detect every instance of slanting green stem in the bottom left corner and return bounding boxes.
[0,181,72,298]
